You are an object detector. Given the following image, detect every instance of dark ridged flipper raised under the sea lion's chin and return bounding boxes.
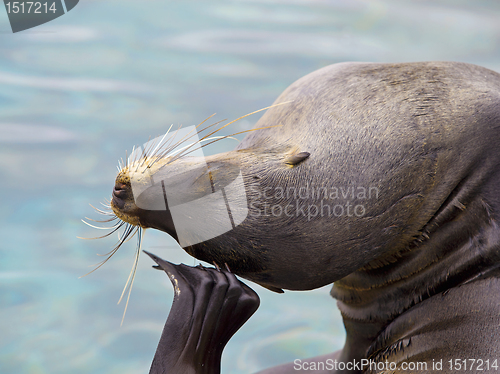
[146,252,260,373]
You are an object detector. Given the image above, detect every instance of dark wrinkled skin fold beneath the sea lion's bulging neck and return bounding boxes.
[331,171,500,326]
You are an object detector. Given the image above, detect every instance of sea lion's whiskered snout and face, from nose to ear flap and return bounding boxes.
[110,134,292,291]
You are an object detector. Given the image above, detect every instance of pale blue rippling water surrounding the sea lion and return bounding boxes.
[0,0,500,374]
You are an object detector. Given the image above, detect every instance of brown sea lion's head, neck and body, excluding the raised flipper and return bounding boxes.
[111,62,500,373]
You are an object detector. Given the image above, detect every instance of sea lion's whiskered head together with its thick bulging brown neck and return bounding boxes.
[111,63,500,296]
